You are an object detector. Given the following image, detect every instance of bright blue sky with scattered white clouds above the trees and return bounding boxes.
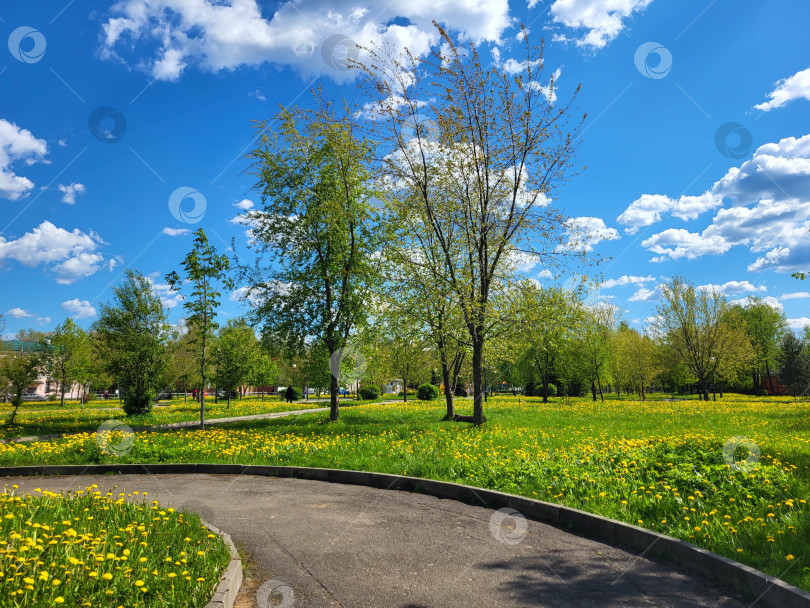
[0,0,810,333]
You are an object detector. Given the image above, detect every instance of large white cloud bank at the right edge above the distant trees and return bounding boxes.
[632,135,810,272]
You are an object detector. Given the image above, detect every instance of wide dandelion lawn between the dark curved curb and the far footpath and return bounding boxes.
[0,395,810,590]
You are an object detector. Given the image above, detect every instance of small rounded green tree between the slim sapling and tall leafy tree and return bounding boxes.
[214,319,259,407]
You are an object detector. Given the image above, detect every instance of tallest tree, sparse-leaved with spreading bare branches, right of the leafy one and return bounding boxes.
[362,25,581,425]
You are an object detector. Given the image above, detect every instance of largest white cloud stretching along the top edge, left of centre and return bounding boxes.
[102,0,504,80]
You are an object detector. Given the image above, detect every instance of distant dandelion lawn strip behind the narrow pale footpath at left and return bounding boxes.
[0,397,329,439]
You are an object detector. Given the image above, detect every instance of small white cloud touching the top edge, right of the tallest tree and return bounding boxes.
[551,0,652,49]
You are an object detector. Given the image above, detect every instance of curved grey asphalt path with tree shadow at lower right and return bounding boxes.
[0,474,750,608]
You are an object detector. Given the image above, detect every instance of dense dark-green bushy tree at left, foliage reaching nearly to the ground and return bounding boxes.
[93,269,169,416]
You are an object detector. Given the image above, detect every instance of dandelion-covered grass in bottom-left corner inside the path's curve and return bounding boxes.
[0,485,230,608]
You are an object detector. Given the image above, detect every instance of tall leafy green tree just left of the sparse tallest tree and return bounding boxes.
[244,94,384,421]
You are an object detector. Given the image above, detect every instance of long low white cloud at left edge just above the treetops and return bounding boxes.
[0,220,110,284]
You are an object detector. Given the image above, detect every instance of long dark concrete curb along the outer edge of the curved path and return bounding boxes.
[0,463,810,608]
